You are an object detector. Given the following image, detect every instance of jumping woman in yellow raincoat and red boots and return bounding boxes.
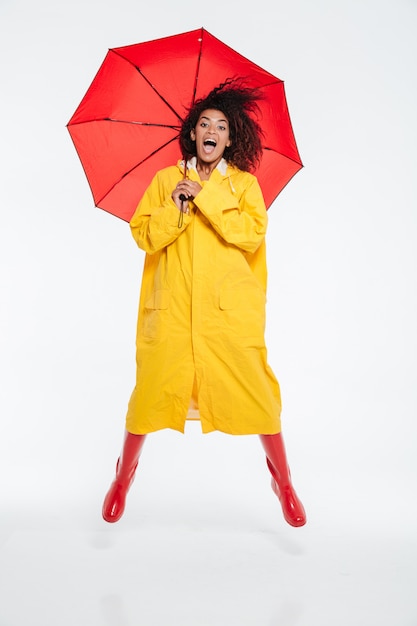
[103,81,306,526]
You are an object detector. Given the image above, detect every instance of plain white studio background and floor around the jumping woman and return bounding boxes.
[0,0,417,626]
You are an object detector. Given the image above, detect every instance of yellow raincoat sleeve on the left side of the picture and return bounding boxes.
[130,172,191,254]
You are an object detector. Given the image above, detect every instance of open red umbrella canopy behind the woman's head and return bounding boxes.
[67,28,302,221]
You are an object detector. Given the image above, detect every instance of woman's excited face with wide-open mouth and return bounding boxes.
[191,109,231,167]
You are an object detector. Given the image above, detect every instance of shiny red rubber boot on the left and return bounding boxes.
[102,431,146,523]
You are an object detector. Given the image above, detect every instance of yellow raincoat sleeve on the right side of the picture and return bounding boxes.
[194,175,268,253]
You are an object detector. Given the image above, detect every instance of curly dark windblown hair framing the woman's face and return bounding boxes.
[179,78,263,172]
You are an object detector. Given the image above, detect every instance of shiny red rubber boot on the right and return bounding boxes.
[259,433,307,526]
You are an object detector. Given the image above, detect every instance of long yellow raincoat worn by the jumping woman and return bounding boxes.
[126,160,281,435]
